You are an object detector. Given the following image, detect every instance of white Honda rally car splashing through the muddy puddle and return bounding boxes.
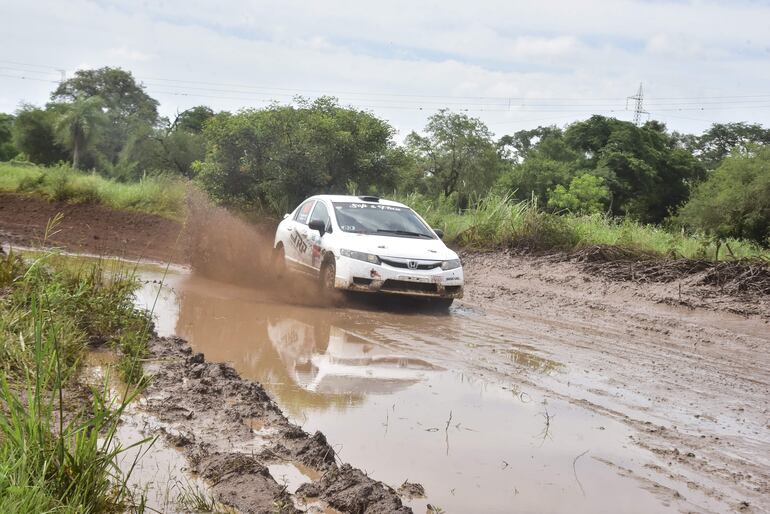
[274,195,464,307]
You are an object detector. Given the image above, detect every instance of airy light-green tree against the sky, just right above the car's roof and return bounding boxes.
[406,109,501,197]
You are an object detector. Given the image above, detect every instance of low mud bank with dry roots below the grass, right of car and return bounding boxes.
[462,246,770,319]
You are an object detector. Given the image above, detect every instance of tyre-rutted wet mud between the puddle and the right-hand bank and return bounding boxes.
[318,254,770,512]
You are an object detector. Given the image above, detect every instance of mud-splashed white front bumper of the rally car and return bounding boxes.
[334,256,465,298]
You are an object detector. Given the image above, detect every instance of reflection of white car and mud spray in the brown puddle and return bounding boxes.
[166,272,439,416]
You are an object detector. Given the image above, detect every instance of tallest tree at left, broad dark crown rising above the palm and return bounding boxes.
[51,67,159,165]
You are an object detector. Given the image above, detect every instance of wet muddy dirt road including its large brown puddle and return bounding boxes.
[0,194,770,513]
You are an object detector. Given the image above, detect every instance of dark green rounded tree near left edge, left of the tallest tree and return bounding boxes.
[13,105,68,165]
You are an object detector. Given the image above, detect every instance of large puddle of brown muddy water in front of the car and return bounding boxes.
[132,269,716,513]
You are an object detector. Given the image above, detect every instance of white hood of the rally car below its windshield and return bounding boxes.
[340,234,457,261]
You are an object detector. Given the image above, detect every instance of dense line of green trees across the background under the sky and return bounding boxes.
[0,68,770,245]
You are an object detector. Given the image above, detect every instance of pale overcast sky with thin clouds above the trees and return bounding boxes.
[0,0,770,139]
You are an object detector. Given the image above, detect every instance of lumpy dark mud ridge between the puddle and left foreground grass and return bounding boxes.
[142,338,412,514]
